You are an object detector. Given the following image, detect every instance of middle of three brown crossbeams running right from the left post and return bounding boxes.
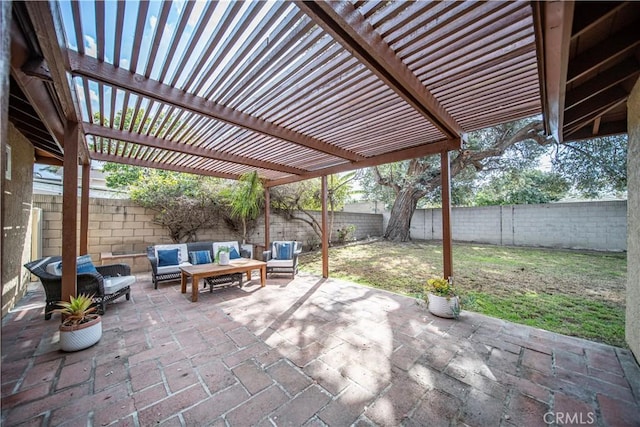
[83,123,306,175]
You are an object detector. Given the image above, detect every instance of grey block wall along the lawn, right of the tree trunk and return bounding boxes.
[411,201,627,251]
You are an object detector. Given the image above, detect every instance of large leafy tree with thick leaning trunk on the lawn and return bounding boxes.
[365,119,626,241]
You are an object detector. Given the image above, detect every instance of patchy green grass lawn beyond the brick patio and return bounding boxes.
[300,241,627,347]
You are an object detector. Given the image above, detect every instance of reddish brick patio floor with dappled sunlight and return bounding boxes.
[1,274,640,426]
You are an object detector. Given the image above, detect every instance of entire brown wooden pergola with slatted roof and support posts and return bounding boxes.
[3,0,640,300]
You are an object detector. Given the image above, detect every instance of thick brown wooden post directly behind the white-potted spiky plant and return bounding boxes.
[62,121,78,301]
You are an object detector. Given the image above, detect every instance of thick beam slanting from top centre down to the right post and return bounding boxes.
[296,1,463,138]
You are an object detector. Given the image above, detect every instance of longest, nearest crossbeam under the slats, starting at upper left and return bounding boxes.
[68,51,363,161]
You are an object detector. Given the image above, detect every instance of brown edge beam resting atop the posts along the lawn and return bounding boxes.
[265,138,462,187]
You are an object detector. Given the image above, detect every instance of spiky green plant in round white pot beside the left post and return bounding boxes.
[53,294,102,351]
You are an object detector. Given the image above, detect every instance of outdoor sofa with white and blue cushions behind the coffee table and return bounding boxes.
[147,241,251,289]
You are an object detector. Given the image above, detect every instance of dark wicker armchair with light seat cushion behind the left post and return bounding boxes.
[24,256,136,320]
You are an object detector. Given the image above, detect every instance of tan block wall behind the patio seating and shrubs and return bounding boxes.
[33,195,383,272]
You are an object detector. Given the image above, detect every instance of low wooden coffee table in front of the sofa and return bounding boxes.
[180,259,267,302]
